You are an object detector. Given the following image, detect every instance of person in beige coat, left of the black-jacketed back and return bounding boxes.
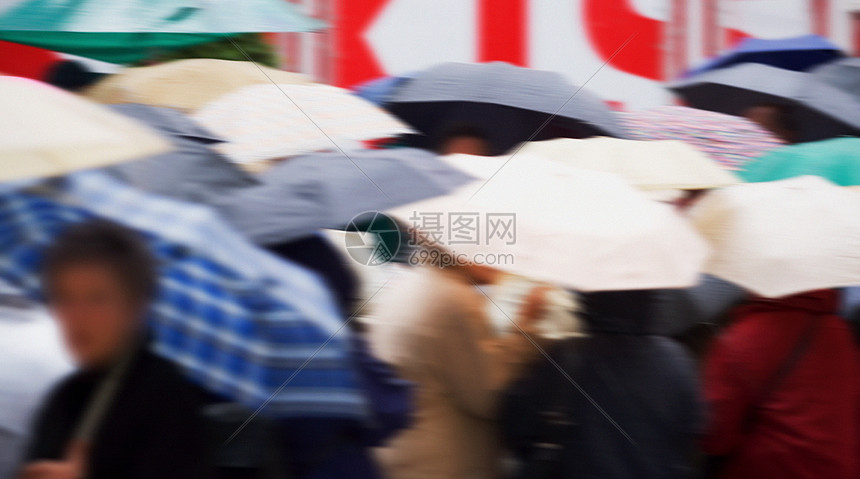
[370,267,537,479]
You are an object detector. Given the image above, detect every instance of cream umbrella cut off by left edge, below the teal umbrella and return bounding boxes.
[0,77,170,181]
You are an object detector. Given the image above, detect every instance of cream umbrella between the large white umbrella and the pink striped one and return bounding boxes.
[516,138,739,190]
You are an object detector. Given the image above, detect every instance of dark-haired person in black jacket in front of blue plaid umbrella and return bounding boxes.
[19,222,213,479]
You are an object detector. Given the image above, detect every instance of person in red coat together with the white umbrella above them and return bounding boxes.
[692,176,860,479]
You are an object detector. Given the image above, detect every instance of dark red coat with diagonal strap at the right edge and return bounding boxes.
[704,290,860,479]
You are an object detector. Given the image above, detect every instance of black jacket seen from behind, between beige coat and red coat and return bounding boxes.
[502,291,701,479]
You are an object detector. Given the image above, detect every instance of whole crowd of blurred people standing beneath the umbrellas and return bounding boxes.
[5,52,860,479]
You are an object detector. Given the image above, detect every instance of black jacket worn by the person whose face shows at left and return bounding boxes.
[25,351,213,479]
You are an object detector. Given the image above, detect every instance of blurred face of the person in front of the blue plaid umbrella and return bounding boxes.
[48,263,141,367]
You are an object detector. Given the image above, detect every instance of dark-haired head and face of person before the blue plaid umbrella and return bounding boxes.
[42,221,157,367]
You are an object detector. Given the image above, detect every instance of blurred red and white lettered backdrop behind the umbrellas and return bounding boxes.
[5,0,860,109]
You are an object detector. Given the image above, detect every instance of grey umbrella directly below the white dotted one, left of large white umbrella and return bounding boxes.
[213,148,473,244]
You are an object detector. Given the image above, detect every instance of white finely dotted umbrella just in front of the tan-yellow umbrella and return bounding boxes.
[193,84,412,164]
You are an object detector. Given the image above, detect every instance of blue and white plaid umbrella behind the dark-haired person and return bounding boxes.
[0,172,366,419]
